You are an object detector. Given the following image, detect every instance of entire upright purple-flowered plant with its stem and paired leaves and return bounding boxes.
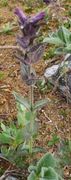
[14,8,48,152]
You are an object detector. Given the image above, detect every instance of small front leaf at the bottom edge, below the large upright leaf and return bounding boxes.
[41,167,59,180]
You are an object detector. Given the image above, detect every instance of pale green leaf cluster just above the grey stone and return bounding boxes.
[43,26,71,54]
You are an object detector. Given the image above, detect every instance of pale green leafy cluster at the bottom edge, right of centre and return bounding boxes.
[28,153,62,180]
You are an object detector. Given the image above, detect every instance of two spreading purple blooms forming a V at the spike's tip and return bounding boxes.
[15,8,45,45]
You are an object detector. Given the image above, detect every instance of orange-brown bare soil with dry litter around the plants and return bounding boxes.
[0,0,71,179]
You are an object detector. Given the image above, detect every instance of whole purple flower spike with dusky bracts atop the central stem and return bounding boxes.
[15,8,45,85]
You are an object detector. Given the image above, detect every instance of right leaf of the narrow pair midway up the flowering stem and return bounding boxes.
[33,99,50,110]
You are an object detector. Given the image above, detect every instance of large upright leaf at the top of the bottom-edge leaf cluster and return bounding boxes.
[37,153,56,173]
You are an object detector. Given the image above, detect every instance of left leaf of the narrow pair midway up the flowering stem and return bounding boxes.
[13,92,30,110]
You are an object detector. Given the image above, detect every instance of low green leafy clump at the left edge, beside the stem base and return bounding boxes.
[0,119,37,167]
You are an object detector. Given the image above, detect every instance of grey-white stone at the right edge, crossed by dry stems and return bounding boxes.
[44,54,71,103]
